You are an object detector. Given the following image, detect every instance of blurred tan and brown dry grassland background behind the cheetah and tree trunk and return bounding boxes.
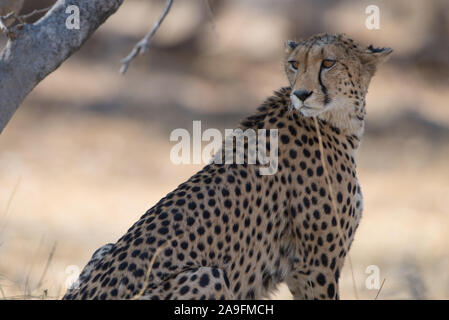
[0,0,449,299]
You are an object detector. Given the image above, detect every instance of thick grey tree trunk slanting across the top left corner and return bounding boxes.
[0,0,123,133]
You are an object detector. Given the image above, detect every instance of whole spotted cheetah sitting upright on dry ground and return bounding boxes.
[64,34,392,300]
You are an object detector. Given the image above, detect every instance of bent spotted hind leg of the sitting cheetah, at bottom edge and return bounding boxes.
[142,267,234,300]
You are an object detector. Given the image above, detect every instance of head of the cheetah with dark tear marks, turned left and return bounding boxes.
[284,34,392,118]
